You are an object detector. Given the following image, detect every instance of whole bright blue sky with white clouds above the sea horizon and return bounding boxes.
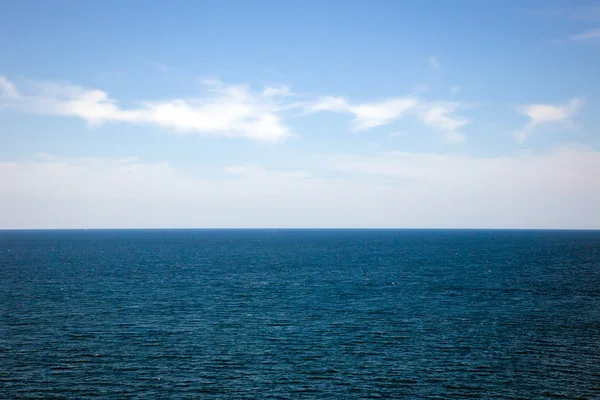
[0,0,600,229]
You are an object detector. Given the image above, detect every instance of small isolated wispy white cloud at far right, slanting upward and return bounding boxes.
[515,97,583,143]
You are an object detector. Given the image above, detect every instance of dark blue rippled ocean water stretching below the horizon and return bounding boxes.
[0,230,600,399]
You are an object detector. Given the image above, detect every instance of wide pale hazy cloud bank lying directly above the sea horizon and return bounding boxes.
[0,148,600,228]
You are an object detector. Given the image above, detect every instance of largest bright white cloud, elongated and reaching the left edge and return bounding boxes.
[0,77,290,142]
